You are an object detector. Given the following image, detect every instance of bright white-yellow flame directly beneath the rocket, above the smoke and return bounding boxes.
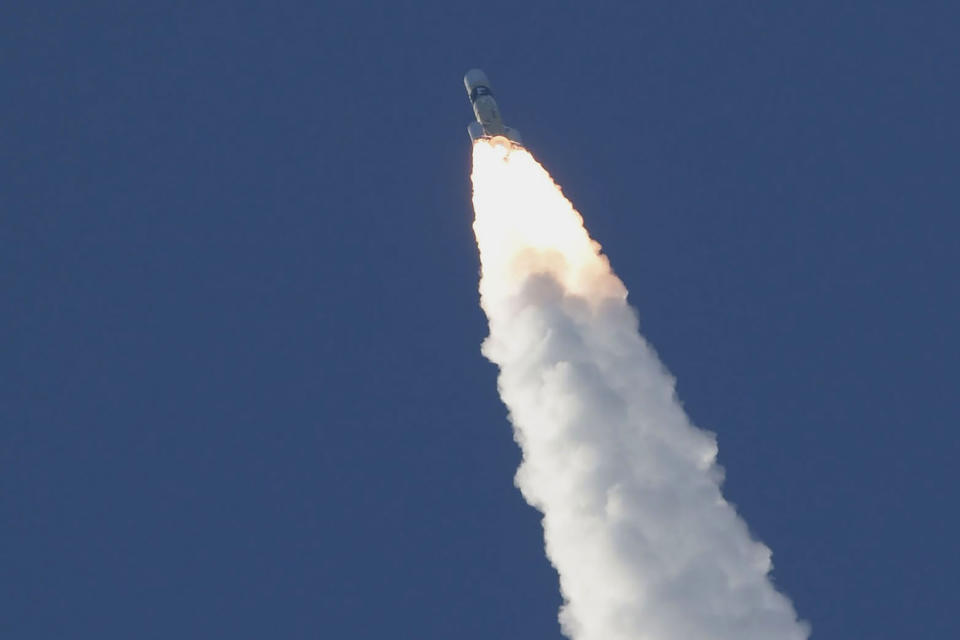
[472,138,626,300]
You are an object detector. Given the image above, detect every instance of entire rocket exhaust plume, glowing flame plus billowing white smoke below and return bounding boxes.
[473,141,809,640]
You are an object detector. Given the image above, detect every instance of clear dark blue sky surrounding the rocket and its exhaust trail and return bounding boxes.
[0,1,960,640]
